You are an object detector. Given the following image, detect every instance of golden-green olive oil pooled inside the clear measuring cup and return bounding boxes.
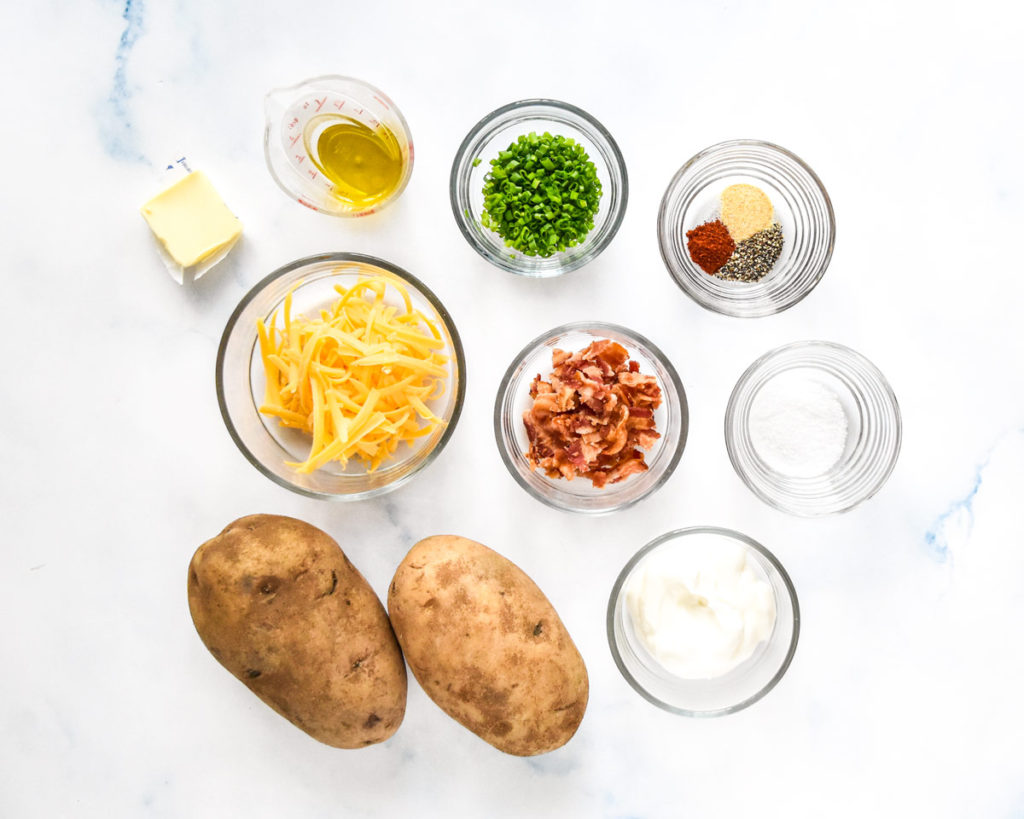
[305,115,402,209]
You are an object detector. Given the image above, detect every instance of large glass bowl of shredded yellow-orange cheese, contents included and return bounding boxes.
[217,253,466,500]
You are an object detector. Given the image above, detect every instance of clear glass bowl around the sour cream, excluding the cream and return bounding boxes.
[607,526,800,717]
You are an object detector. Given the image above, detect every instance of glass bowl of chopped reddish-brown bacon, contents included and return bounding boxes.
[495,321,689,514]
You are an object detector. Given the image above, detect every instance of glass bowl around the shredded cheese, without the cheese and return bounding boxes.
[217,253,466,501]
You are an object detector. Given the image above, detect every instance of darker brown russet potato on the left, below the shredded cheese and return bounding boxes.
[188,515,408,748]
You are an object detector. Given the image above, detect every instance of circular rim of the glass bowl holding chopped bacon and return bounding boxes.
[493,321,690,517]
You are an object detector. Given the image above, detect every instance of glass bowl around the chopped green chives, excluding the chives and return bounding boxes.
[450,99,629,278]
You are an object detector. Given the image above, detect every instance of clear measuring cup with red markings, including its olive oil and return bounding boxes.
[263,75,414,216]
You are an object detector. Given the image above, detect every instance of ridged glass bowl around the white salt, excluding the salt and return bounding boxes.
[725,341,902,517]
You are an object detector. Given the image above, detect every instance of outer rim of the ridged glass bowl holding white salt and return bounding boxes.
[724,339,903,518]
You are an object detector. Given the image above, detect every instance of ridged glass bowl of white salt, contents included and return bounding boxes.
[725,341,902,517]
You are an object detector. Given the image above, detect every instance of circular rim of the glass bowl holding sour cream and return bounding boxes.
[605,526,800,719]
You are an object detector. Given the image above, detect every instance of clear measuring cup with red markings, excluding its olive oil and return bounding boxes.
[263,75,413,216]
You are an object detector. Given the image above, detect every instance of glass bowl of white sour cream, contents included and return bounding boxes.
[607,526,800,717]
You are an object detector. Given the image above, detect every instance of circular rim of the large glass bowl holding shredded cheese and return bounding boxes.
[214,251,466,502]
